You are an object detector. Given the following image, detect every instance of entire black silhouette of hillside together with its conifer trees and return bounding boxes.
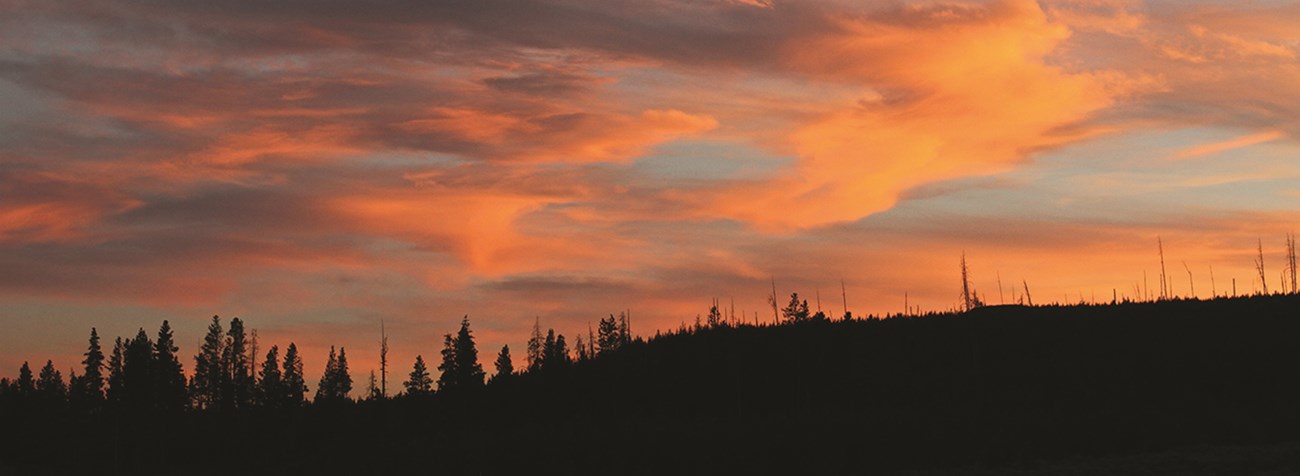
[0,294,1300,475]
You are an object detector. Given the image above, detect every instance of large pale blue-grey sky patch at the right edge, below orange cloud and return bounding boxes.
[857,127,1300,222]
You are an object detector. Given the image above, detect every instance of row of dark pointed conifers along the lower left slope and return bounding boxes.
[0,313,644,414]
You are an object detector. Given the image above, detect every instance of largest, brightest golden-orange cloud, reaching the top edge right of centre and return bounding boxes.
[716,0,1122,230]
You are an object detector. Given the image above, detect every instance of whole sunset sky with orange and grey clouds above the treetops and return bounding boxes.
[0,0,1300,389]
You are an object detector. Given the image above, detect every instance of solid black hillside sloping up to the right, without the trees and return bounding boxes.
[0,295,1300,475]
